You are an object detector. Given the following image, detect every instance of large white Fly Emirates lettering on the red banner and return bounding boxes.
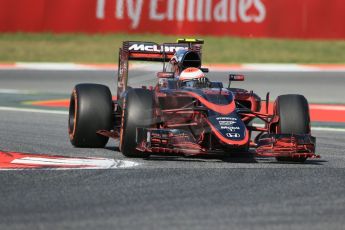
[96,0,267,29]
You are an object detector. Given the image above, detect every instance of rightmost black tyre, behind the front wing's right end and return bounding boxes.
[275,94,310,162]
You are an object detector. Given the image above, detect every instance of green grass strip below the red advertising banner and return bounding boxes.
[0,33,345,64]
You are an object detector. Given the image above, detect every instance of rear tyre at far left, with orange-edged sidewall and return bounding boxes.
[68,84,113,148]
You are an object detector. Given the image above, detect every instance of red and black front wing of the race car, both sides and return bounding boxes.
[132,128,319,158]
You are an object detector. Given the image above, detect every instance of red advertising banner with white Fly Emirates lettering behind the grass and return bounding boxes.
[0,0,345,39]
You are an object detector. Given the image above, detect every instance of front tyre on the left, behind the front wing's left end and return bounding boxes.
[120,89,154,157]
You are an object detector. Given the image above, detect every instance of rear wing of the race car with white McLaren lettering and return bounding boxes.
[117,39,204,98]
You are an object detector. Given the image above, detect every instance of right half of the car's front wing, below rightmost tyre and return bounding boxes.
[256,134,320,158]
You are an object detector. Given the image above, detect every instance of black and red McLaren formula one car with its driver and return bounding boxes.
[68,39,317,162]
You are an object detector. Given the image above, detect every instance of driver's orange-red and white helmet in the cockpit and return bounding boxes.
[178,67,210,88]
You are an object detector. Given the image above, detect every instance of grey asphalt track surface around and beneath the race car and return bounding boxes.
[0,70,345,229]
